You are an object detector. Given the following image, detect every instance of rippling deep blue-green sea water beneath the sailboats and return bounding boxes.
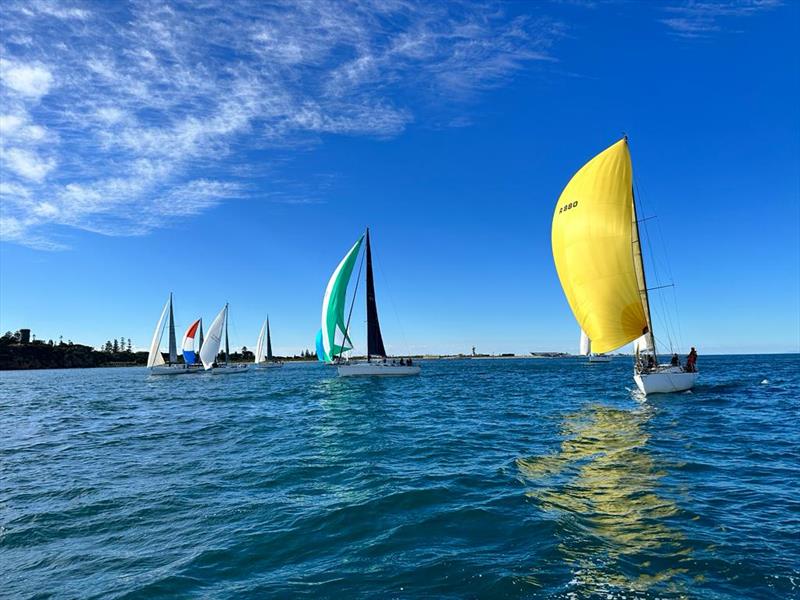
[0,355,800,599]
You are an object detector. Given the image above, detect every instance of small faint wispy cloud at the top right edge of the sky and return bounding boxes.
[661,0,782,38]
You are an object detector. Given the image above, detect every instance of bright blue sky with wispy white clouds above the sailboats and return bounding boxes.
[0,0,800,353]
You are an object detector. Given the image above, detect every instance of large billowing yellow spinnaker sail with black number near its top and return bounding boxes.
[552,139,648,353]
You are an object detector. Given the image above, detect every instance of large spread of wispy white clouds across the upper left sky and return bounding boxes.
[0,0,563,249]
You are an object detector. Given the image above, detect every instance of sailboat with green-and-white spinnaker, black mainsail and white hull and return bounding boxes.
[316,229,420,377]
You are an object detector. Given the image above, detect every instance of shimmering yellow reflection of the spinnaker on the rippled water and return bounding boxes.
[517,405,691,594]
